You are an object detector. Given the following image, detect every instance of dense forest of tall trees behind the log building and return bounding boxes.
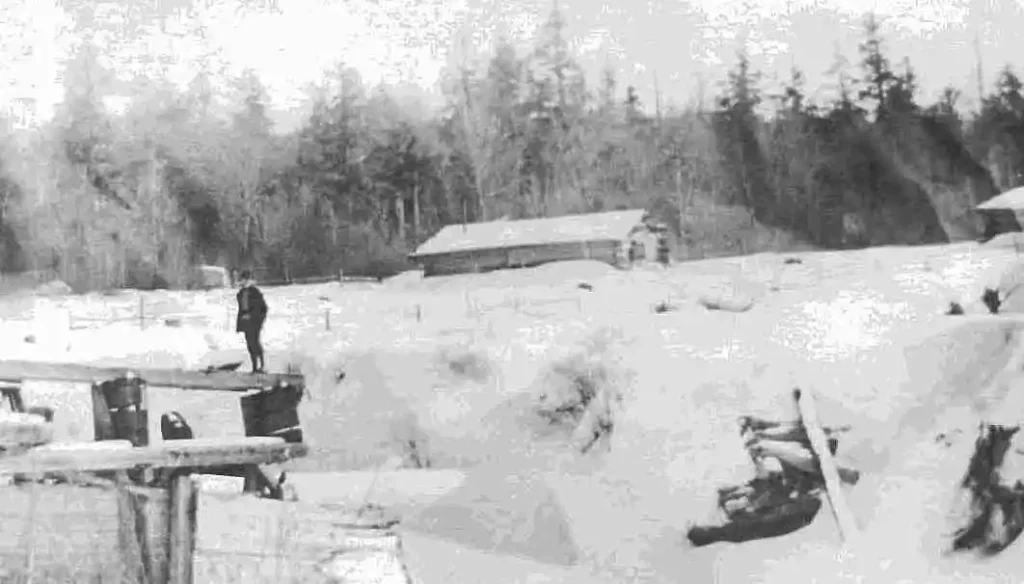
[0,7,1024,290]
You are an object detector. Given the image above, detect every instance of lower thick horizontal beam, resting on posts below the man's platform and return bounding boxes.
[0,437,306,475]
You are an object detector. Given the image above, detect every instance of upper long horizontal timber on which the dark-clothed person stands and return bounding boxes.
[0,360,305,391]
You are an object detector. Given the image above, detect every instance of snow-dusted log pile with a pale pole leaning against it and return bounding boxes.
[687,389,860,546]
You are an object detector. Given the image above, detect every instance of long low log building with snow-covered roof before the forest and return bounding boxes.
[410,210,649,277]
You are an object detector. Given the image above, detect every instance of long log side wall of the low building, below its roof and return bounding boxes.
[417,240,628,277]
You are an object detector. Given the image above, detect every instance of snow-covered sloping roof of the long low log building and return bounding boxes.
[412,209,646,257]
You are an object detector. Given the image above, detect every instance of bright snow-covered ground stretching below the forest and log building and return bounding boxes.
[0,238,1024,583]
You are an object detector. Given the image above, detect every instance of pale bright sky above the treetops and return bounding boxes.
[0,0,1024,128]
